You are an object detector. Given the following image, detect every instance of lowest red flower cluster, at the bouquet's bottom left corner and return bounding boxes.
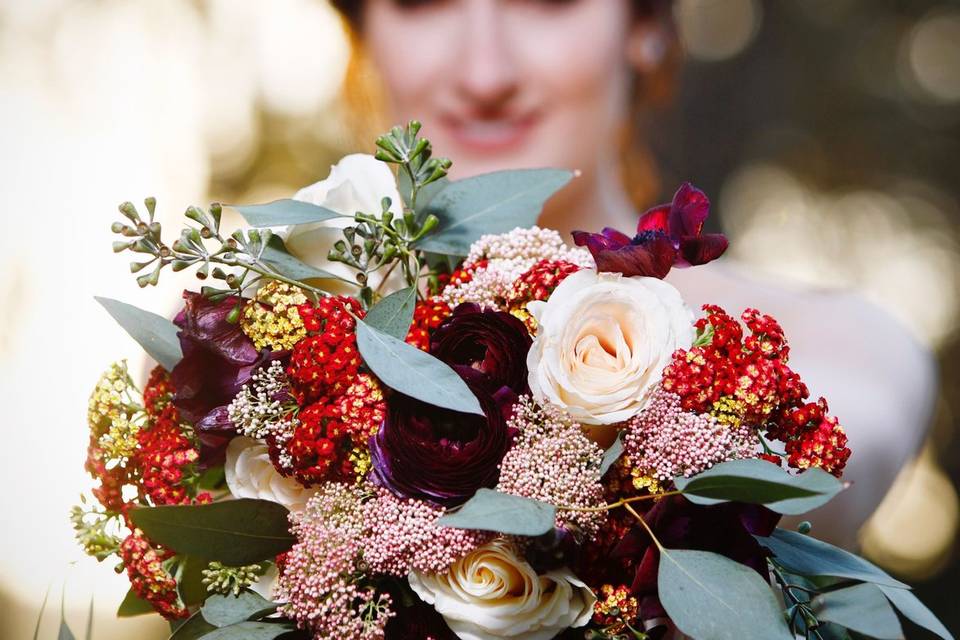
[120,529,190,620]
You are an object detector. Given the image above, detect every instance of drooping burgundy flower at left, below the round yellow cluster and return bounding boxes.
[170,291,275,466]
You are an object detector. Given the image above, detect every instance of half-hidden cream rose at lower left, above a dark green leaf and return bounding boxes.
[223,436,316,511]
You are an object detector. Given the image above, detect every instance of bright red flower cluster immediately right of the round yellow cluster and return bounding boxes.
[287,296,363,405]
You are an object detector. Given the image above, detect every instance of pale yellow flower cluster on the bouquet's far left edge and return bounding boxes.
[87,361,144,458]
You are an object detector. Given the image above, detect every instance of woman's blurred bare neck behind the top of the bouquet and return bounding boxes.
[538,149,637,242]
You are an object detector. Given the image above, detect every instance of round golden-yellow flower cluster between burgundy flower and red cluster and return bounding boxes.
[240,280,307,351]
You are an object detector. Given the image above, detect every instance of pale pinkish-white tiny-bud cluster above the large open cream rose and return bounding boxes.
[441,227,594,308]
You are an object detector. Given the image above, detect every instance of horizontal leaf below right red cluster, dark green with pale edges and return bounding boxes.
[674,459,844,515]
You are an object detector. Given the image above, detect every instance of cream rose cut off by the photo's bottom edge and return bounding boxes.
[408,539,597,640]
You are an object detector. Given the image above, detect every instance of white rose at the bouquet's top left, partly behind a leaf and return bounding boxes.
[275,153,403,286]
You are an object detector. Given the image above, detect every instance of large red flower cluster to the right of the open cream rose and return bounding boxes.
[663,305,850,476]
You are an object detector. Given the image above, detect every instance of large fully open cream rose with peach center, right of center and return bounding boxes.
[527,270,694,425]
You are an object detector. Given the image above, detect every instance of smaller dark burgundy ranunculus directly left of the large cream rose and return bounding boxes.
[430,303,533,395]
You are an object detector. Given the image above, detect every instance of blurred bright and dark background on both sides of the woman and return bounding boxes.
[0,0,960,640]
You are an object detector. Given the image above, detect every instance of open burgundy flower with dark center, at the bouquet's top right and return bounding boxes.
[573,182,727,278]
